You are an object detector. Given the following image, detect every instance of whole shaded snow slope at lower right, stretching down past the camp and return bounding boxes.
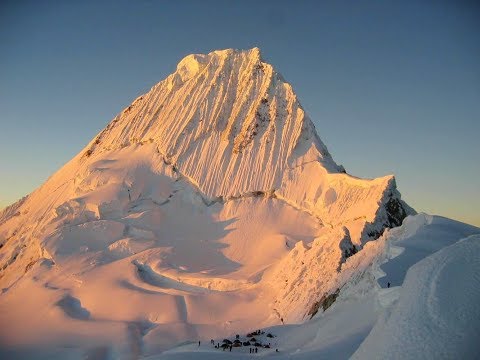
[141,214,480,360]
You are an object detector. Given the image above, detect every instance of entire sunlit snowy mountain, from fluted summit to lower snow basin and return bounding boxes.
[0,48,413,356]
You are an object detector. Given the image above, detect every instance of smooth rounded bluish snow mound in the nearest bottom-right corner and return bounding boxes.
[353,235,480,359]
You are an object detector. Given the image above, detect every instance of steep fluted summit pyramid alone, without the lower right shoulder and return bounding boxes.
[85,48,342,197]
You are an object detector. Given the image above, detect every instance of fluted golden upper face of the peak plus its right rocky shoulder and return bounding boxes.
[79,48,405,242]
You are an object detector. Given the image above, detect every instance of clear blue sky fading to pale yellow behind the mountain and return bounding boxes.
[0,0,480,225]
